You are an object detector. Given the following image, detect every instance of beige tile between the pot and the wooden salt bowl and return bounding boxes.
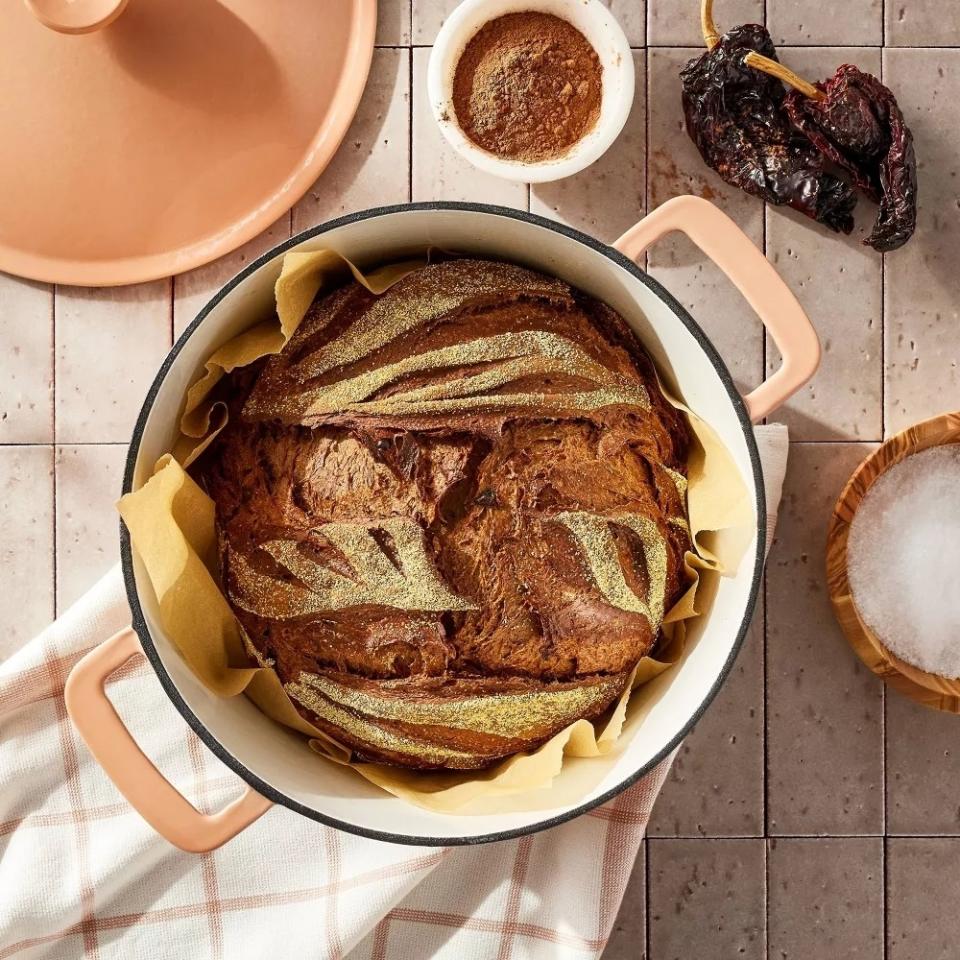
[767,443,883,836]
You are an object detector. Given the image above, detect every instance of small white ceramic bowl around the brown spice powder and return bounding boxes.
[427,0,634,183]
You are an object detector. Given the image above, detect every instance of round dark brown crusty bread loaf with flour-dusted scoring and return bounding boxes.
[194,260,689,769]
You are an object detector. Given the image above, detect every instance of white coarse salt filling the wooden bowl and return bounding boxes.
[847,444,960,677]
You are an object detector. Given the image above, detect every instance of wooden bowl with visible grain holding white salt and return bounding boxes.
[827,413,960,713]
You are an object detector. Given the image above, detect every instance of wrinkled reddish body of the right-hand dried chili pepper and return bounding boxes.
[786,63,917,251]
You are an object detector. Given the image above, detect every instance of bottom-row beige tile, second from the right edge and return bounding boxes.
[767,837,884,960]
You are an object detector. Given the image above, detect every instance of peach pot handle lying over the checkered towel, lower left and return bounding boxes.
[63,627,272,853]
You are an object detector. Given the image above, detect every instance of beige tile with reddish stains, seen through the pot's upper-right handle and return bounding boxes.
[647,49,763,392]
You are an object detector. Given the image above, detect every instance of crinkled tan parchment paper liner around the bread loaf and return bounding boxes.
[118,250,753,813]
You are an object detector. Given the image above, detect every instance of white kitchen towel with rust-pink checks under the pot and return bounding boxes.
[0,426,787,960]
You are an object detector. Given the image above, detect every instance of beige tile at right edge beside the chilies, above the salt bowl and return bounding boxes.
[884,46,960,434]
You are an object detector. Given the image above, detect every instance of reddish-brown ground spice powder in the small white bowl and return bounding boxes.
[453,11,603,162]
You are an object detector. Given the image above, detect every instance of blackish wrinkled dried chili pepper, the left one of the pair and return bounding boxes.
[680,24,857,233]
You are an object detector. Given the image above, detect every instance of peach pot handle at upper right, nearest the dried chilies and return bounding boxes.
[613,196,820,423]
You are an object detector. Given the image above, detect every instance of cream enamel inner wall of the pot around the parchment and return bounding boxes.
[131,207,762,842]
